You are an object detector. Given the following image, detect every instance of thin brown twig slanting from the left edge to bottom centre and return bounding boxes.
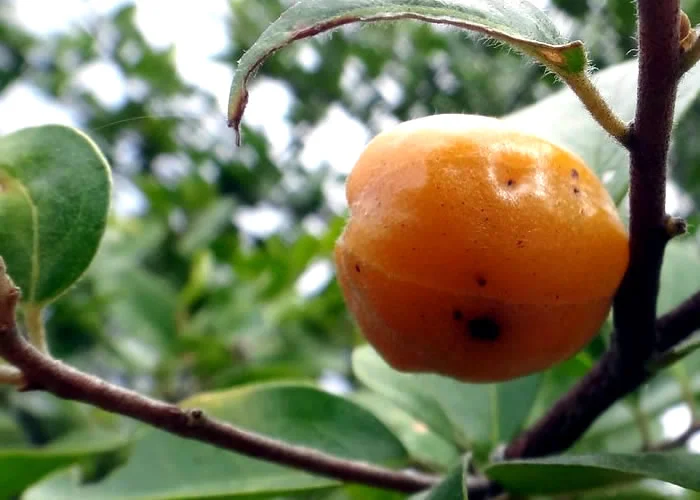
[0,291,440,493]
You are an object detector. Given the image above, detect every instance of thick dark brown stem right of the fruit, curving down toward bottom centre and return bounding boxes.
[505,0,680,458]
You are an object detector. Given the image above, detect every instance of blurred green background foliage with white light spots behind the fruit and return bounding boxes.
[0,0,700,500]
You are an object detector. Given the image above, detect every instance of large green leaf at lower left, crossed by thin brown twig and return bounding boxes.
[24,384,407,500]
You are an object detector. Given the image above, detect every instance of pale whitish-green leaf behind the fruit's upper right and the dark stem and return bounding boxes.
[504,60,700,204]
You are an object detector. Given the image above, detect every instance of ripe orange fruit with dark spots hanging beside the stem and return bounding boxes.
[335,115,629,382]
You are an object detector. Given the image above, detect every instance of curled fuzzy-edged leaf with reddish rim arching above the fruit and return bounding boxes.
[228,0,587,143]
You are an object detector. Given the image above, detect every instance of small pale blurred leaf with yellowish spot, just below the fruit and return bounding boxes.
[352,391,459,470]
